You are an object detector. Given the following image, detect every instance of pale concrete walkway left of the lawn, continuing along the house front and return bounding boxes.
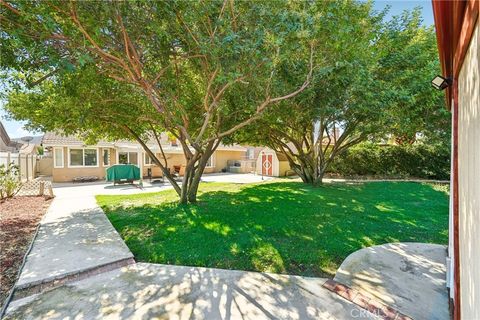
[16,173,272,296]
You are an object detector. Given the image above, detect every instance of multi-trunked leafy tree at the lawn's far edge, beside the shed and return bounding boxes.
[239,2,449,185]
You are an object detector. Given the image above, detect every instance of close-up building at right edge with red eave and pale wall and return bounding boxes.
[433,0,480,320]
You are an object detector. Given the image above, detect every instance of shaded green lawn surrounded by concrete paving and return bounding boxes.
[97,181,448,276]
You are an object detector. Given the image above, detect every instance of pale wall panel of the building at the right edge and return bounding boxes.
[458,23,480,319]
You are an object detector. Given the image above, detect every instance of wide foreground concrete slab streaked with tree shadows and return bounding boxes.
[3,263,376,320]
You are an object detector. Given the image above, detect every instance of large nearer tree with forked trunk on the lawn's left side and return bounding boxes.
[0,0,312,203]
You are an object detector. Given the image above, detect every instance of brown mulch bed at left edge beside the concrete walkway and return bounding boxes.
[0,197,51,306]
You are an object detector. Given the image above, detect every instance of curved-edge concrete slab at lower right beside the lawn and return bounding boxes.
[334,243,450,320]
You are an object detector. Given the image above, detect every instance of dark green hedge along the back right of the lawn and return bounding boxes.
[327,142,450,180]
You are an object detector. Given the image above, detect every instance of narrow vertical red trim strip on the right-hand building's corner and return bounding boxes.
[452,79,461,320]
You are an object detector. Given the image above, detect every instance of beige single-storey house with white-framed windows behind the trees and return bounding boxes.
[42,132,248,182]
